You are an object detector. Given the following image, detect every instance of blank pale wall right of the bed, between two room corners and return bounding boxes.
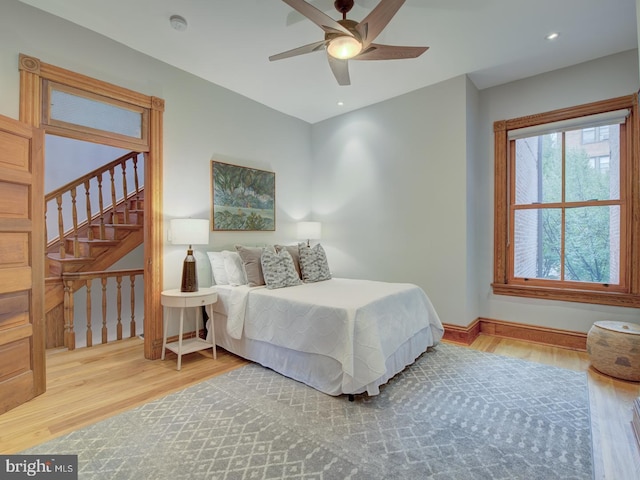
[312,76,475,325]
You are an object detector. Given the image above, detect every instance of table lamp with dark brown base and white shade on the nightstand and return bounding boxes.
[171,218,209,292]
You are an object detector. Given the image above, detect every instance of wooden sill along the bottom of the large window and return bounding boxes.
[491,283,640,308]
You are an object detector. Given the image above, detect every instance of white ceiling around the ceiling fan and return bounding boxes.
[21,0,638,123]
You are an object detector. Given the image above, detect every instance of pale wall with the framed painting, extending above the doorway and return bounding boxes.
[0,0,311,288]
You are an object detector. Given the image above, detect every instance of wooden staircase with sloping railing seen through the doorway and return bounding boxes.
[45,152,144,348]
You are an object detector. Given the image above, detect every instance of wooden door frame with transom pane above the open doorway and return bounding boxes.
[19,54,164,366]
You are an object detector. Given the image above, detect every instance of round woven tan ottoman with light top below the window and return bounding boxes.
[587,322,640,382]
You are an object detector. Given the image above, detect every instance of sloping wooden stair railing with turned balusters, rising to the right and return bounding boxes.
[45,152,141,258]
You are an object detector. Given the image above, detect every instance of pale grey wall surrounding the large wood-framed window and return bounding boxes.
[477,50,640,332]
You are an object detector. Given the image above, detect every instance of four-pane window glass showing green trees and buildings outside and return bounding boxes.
[510,124,622,284]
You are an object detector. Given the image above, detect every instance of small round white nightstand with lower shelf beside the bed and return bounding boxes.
[160,287,218,370]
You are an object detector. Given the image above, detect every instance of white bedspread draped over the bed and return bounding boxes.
[212,278,444,391]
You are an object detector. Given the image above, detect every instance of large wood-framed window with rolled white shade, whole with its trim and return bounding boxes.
[493,95,640,306]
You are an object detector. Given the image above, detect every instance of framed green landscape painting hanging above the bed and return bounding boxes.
[211,160,276,231]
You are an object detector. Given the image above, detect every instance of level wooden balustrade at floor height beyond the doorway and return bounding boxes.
[62,268,144,350]
